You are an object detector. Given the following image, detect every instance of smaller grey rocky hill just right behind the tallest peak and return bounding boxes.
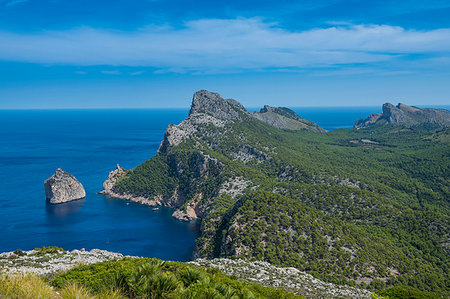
[253,105,326,132]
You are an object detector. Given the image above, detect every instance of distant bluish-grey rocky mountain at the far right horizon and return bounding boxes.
[354,103,450,128]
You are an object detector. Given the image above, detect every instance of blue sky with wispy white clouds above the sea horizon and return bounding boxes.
[0,0,450,109]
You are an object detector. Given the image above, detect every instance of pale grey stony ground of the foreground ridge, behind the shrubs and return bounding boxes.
[0,247,372,298]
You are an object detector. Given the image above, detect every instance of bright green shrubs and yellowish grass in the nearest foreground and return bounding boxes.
[0,258,300,299]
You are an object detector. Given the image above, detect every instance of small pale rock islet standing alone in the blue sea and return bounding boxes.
[44,168,86,204]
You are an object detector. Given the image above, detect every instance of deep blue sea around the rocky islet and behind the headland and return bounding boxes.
[0,107,442,261]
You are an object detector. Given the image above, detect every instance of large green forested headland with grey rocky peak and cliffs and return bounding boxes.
[104,90,450,295]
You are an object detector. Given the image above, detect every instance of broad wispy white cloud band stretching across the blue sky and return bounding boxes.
[0,18,450,74]
